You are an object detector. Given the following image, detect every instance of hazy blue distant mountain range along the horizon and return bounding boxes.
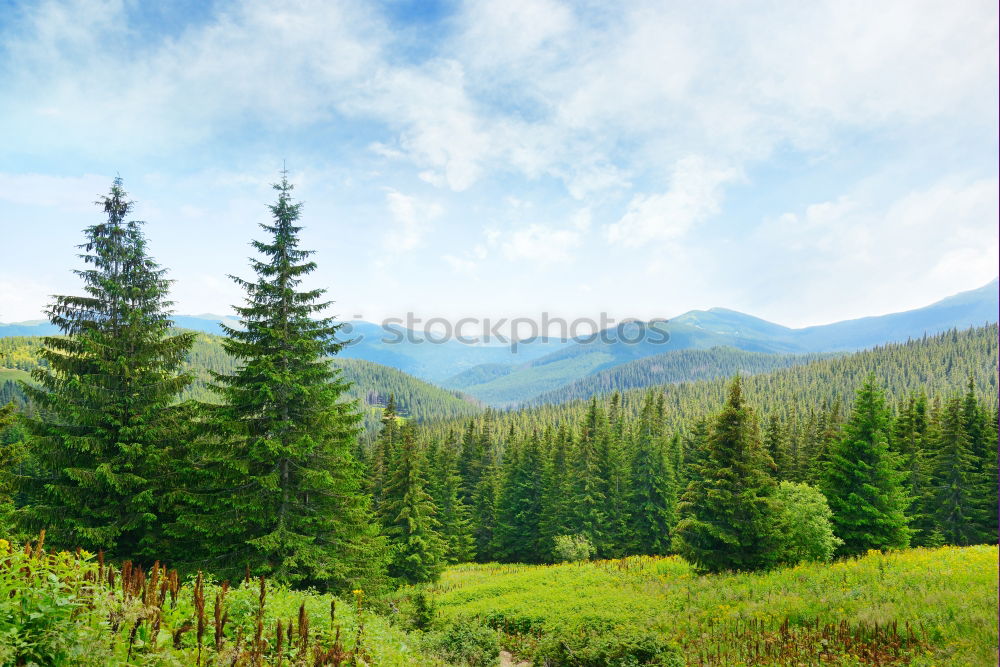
[0,280,1000,407]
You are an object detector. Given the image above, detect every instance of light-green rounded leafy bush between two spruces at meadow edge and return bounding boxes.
[774,482,842,565]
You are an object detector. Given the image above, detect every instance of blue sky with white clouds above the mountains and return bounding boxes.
[0,0,1000,326]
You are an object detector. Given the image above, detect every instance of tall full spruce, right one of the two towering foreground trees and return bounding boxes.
[199,174,385,590]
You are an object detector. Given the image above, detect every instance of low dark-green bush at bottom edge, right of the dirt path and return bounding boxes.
[534,627,684,667]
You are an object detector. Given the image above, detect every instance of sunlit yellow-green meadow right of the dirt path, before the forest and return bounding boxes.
[430,546,998,665]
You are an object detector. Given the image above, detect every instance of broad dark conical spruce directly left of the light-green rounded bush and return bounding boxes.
[674,378,781,572]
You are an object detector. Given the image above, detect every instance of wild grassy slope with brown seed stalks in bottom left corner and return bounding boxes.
[0,534,443,667]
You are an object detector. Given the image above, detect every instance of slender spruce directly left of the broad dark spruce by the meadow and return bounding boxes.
[628,394,679,555]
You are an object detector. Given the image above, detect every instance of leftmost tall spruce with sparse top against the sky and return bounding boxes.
[23,178,194,559]
